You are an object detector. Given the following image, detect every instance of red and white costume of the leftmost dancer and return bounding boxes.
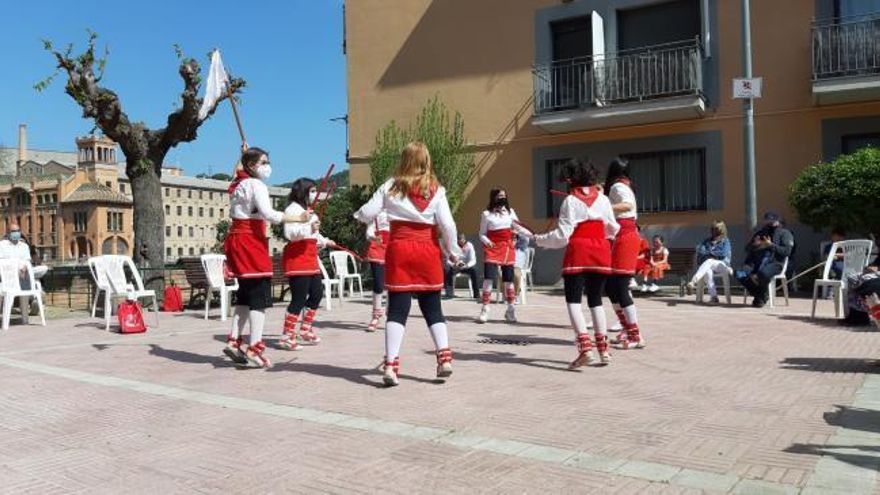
[223,177,284,278]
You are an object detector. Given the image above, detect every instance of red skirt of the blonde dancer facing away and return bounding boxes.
[385,221,443,292]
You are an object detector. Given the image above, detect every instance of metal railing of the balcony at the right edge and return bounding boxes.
[811,13,880,81]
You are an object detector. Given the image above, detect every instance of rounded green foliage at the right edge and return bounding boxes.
[789,147,880,235]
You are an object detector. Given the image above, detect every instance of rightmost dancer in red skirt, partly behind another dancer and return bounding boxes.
[605,158,645,349]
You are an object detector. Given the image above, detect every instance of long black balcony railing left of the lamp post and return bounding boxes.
[534,39,703,115]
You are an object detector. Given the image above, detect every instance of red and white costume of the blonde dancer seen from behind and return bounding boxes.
[355,180,461,292]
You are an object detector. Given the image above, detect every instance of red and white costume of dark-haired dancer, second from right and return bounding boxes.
[535,187,620,274]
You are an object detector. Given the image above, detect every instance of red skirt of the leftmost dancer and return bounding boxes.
[223,218,272,278]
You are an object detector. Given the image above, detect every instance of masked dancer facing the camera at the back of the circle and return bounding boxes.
[477,188,532,323]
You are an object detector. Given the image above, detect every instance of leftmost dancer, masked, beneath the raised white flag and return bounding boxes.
[223,147,307,368]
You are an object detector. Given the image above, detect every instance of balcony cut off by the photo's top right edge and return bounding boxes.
[812,14,880,104]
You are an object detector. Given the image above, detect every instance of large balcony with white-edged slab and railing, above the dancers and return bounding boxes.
[532,39,706,133]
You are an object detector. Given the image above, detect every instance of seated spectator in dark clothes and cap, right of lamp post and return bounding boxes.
[736,211,794,308]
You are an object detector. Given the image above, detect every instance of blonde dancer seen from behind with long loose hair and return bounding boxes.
[354,142,461,386]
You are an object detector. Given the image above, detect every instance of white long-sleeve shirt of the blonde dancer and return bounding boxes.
[354,179,461,258]
